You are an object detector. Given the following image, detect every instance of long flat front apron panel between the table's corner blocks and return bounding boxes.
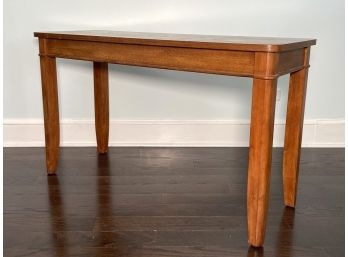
[42,39,254,76]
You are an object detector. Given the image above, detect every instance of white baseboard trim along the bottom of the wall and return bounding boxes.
[4,119,345,147]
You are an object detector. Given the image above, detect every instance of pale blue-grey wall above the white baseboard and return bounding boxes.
[4,0,344,146]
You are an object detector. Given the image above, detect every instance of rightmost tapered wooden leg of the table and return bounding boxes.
[283,68,308,207]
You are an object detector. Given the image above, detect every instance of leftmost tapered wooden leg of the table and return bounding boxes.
[40,56,59,174]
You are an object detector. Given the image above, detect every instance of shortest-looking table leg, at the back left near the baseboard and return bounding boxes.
[93,62,109,153]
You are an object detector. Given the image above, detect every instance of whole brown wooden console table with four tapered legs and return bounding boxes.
[34,31,316,247]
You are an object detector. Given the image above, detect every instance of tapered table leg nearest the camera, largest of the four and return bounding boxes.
[247,79,277,247]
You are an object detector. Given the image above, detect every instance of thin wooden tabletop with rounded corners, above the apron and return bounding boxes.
[34,30,316,52]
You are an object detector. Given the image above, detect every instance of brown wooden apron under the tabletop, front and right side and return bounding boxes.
[40,38,304,79]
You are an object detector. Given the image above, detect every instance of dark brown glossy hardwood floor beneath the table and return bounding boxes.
[4,147,344,257]
